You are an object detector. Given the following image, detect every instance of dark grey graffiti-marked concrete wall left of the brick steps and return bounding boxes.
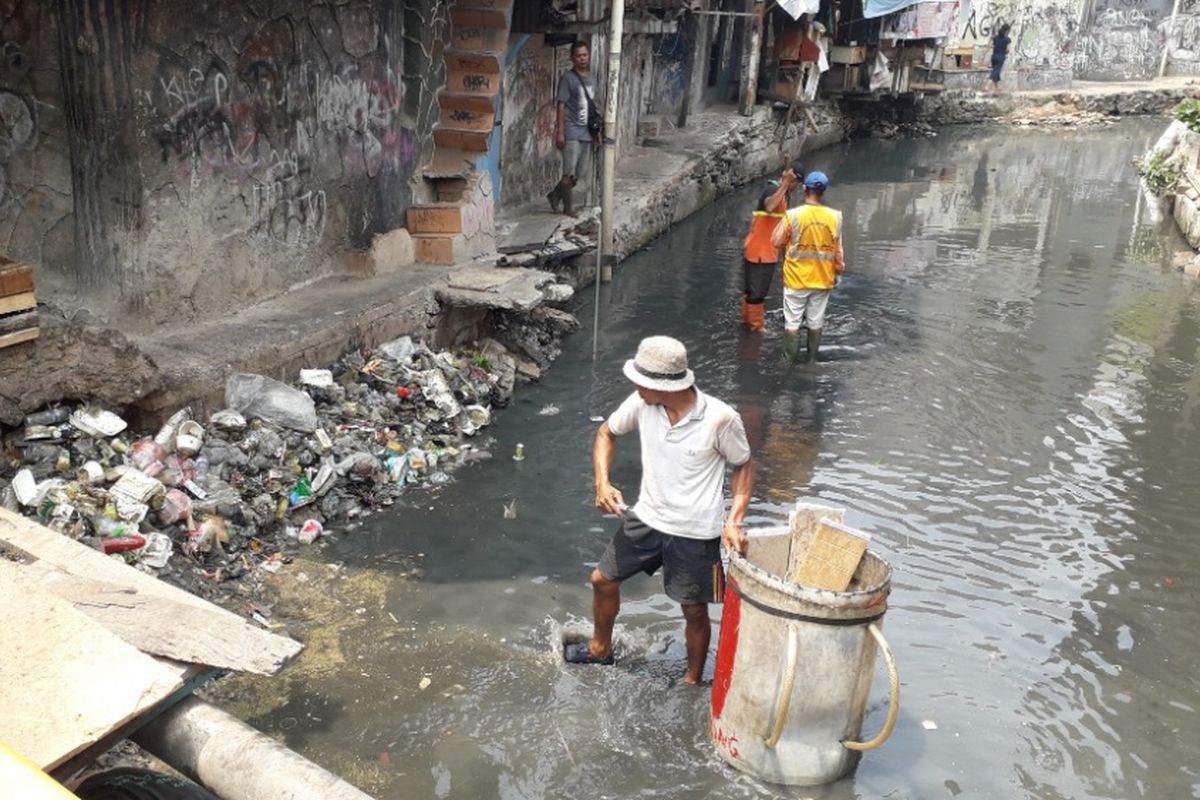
[0,0,449,330]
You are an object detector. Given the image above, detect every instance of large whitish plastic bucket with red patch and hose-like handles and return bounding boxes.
[708,504,900,786]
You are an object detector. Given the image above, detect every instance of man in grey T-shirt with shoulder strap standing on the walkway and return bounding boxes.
[546,42,604,217]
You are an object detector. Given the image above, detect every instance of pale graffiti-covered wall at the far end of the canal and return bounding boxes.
[948,0,1200,89]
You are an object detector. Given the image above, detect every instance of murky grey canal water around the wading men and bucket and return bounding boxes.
[213,121,1200,800]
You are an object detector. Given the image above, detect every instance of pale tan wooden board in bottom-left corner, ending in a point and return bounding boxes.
[0,582,186,771]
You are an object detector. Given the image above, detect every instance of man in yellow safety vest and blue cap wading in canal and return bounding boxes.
[770,172,846,363]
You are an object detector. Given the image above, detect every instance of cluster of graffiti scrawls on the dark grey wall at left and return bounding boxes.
[149,20,415,247]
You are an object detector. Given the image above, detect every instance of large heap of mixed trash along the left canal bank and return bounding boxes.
[0,337,521,604]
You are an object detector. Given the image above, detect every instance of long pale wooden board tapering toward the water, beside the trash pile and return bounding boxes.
[0,509,302,675]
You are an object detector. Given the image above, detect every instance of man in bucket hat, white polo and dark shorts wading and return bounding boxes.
[563,336,754,684]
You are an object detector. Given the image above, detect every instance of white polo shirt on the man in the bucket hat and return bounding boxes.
[608,389,750,539]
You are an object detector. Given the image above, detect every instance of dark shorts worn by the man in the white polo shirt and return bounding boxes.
[599,512,725,606]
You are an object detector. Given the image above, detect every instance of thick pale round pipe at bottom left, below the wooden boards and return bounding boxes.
[133,697,373,800]
